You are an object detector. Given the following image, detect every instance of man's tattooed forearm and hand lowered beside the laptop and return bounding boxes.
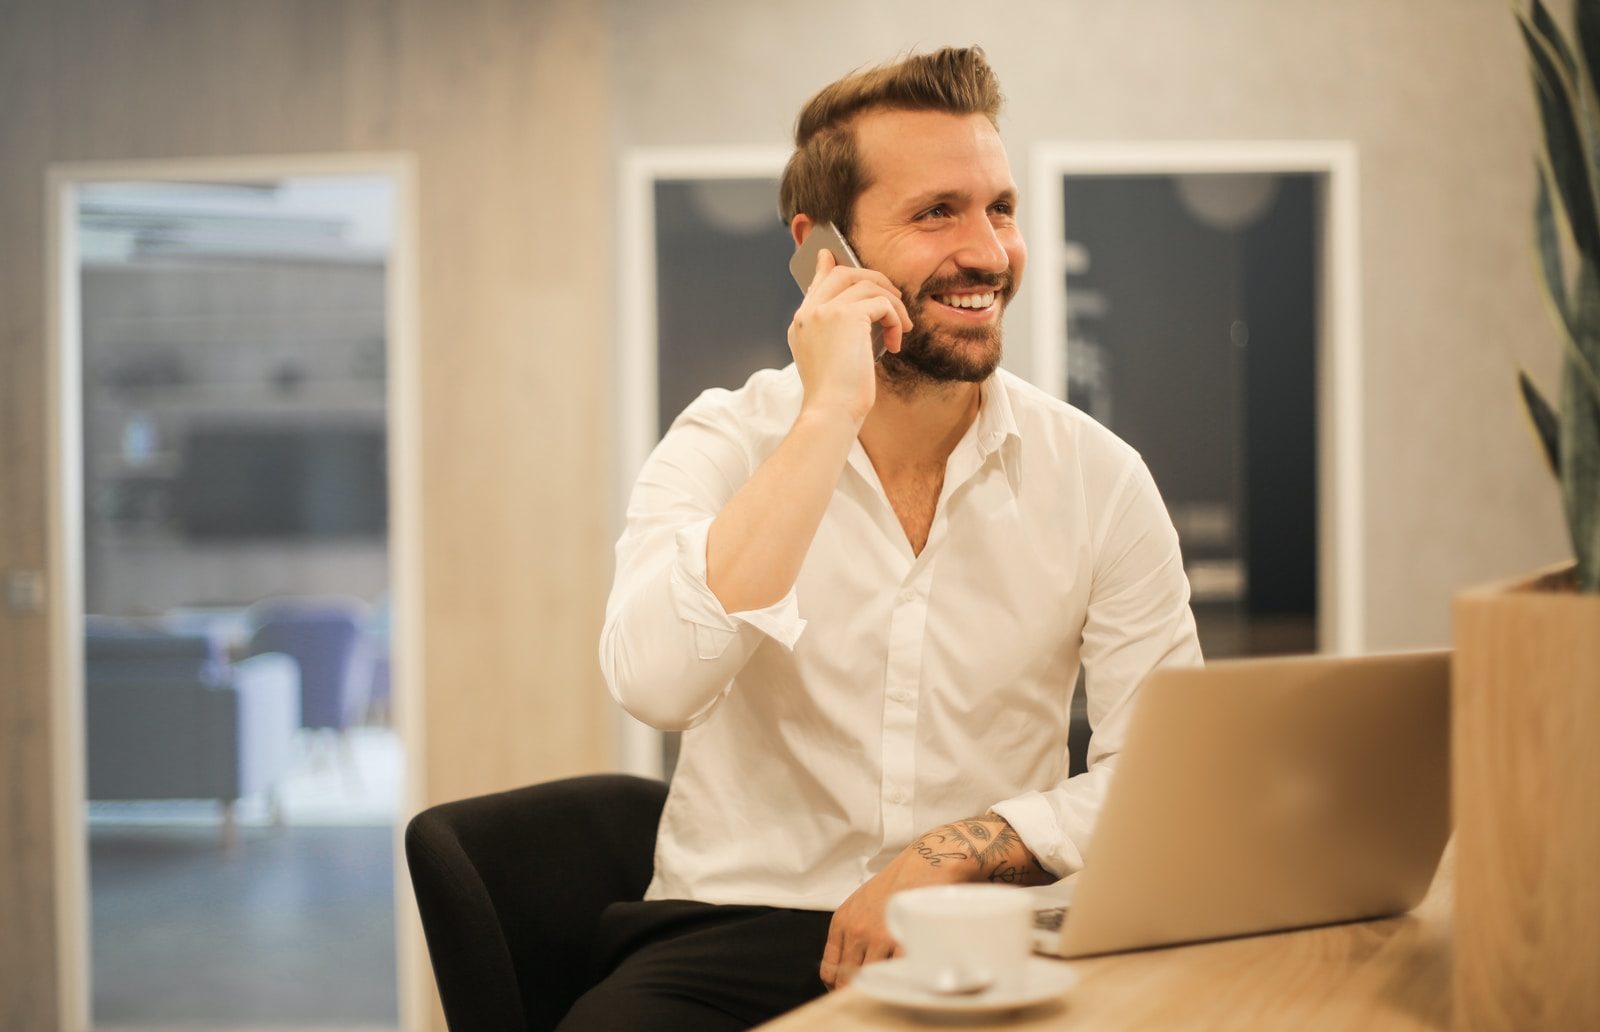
[818,813,1054,989]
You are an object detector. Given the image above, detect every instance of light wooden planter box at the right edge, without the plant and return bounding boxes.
[1451,566,1600,1032]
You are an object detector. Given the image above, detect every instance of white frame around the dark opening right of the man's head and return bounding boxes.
[1029,139,1366,654]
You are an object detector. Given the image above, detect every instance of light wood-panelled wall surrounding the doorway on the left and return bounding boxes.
[0,0,611,1032]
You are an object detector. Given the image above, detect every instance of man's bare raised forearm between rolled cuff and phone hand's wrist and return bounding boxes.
[706,403,858,613]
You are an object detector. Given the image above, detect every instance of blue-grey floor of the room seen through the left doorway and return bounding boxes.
[90,733,400,1029]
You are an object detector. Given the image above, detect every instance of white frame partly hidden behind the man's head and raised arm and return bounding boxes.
[611,146,792,778]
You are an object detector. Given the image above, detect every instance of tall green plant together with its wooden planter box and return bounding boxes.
[1453,0,1600,1030]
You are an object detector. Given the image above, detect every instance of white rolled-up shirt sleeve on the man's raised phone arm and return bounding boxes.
[600,398,805,731]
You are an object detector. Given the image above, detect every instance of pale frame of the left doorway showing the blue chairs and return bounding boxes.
[45,152,432,1032]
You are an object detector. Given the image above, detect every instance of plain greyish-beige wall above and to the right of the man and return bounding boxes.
[611,0,1570,648]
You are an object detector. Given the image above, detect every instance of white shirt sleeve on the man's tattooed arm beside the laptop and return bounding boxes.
[992,461,1202,877]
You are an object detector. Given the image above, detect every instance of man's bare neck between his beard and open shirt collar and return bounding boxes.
[858,379,982,478]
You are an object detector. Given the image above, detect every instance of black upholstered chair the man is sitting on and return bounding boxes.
[405,774,667,1032]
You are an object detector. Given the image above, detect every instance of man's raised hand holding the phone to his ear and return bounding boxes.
[789,250,910,429]
